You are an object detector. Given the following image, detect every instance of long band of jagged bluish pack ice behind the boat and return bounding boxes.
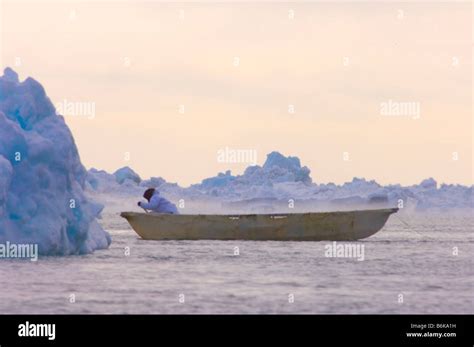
[86,151,474,214]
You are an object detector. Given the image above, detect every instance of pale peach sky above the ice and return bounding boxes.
[0,0,474,185]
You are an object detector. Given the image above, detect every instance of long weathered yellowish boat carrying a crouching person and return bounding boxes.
[120,208,398,241]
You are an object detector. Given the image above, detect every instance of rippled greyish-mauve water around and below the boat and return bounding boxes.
[0,214,474,313]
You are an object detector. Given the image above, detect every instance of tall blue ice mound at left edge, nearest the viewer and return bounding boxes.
[0,68,111,255]
